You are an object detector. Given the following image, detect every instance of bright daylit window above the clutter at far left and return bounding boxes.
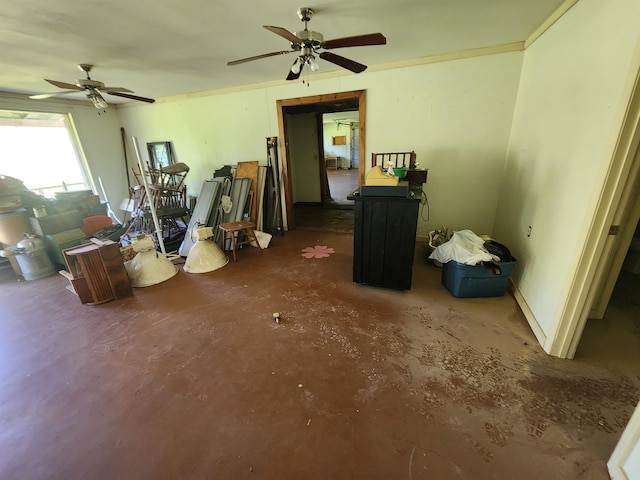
[0,110,90,197]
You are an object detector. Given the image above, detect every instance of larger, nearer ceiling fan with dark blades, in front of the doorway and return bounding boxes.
[227,7,387,80]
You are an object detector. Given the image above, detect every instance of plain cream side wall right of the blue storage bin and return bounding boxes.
[494,0,640,344]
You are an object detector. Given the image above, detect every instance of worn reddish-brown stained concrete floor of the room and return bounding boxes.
[0,211,640,480]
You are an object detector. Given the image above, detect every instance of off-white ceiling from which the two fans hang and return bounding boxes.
[0,0,565,103]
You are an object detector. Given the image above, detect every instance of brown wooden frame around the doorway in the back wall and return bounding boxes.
[276,90,366,230]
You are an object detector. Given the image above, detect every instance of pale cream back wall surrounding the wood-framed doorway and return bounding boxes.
[119,52,523,237]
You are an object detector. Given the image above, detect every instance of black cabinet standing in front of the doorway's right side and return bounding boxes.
[350,194,420,290]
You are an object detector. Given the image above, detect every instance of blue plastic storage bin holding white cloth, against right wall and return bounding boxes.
[442,258,516,298]
